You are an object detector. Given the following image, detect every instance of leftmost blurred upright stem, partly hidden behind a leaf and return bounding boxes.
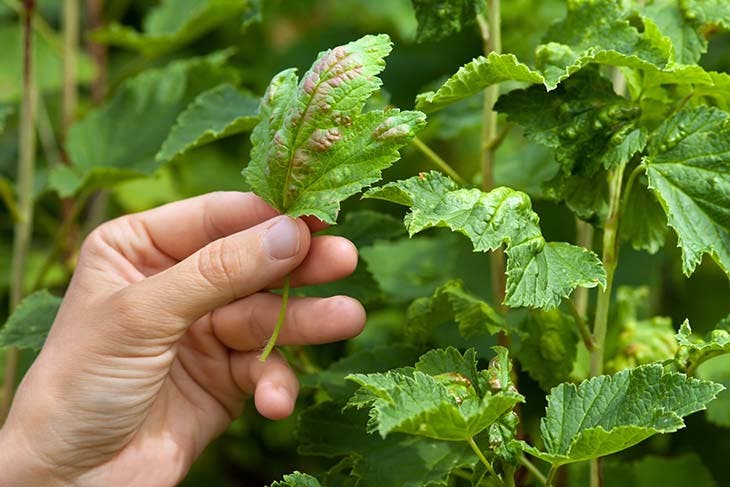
[0,0,36,423]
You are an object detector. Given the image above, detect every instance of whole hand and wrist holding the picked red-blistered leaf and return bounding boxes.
[0,192,365,487]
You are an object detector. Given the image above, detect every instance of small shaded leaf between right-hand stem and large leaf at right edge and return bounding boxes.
[619,174,667,254]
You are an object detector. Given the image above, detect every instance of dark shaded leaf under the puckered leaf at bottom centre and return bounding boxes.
[298,402,476,487]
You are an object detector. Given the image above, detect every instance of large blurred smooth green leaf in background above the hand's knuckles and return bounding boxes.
[54,53,235,197]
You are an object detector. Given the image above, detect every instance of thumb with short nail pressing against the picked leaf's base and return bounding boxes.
[118,216,311,337]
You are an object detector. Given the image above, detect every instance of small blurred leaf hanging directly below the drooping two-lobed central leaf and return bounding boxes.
[517,309,578,390]
